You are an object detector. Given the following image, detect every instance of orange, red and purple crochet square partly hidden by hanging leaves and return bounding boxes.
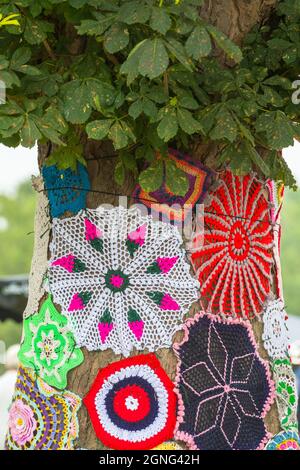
[133,149,212,224]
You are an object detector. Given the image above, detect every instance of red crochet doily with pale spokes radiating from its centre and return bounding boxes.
[192,171,273,318]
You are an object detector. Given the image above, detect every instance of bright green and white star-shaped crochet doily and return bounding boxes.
[18,296,83,389]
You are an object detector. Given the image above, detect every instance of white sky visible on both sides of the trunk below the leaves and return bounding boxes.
[0,142,300,194]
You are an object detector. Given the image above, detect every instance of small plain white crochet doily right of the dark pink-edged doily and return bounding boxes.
[262,299,289,358]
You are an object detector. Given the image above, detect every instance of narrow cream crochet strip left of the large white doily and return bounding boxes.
[24,177,51,318]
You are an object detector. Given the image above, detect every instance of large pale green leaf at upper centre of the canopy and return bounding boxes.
[138,38,169,80]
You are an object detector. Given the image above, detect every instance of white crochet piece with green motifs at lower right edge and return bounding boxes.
[272,359,298,430]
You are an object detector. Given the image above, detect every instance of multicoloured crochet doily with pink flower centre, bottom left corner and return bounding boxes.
[5,367,81,450]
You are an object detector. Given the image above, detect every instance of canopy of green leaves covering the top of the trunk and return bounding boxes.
[0,0,300,194]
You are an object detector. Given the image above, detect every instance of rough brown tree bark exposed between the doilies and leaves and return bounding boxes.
[33,0,279,449]
